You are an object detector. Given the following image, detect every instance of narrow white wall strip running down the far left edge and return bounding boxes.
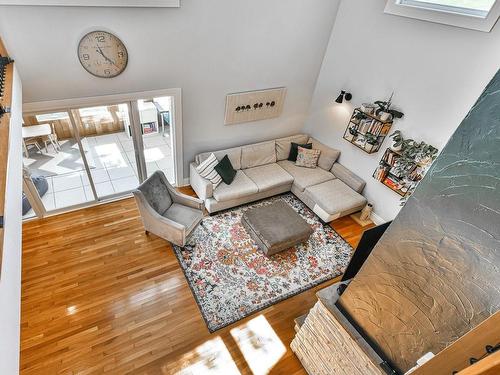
[0,69,23,375]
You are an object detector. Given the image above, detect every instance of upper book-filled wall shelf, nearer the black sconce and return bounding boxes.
[343,108,393,154]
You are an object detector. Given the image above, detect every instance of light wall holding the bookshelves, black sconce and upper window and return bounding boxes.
[305,0,500,220]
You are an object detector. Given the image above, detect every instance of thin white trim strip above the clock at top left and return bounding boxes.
[0,0,181,8]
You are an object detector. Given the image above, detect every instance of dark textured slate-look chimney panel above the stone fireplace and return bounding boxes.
[339,71,500,373]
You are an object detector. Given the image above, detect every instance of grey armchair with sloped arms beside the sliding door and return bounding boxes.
[133,171,203,246]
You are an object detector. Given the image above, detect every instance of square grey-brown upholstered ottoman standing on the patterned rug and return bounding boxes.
[241,200,313,256]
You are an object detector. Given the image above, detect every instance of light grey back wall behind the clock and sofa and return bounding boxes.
[0,0,339,176]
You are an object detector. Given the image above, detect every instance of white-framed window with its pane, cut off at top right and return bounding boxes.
[385,0,500,32]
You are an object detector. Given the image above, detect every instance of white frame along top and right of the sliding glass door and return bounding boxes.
[23,88,184,186]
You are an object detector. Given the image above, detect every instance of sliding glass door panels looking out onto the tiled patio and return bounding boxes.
[23,92,176,218]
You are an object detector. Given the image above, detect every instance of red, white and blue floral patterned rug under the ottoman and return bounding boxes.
[174,194,353,332]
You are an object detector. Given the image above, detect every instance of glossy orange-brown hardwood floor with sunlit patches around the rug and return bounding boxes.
[21,189,374,375]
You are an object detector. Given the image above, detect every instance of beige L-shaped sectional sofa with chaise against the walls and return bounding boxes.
[190,134,366,222]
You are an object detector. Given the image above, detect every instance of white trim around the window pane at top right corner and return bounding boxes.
[384,0,500,32]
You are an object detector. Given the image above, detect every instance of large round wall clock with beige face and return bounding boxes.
[78,31,128,78]
